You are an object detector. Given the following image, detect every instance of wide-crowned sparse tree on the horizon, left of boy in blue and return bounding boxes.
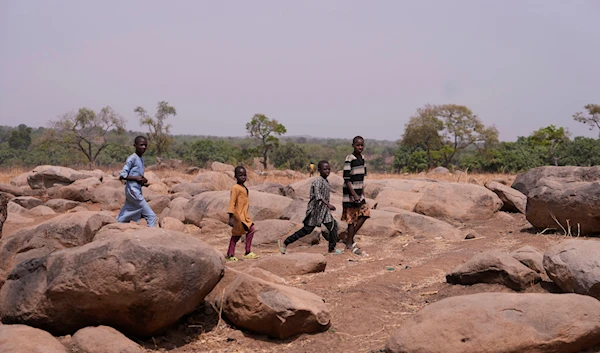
[49,106,125,168]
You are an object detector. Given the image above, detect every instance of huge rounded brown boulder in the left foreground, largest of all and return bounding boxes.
[0,228,224,337]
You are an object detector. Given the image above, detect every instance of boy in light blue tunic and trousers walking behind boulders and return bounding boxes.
[117,136,157,227]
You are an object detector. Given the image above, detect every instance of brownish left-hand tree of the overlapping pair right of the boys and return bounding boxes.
[401,104,444,168]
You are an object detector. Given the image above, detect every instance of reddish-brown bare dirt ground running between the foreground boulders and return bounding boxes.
[131,215,564,353]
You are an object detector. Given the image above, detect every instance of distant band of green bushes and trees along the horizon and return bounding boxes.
[0,125,600,173]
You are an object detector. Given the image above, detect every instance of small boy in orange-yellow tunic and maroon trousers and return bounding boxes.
[225,166,258,262]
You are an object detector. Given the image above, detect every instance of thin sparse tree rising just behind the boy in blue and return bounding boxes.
[133,101,177,157]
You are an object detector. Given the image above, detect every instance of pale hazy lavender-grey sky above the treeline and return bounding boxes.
[0,0,600,141]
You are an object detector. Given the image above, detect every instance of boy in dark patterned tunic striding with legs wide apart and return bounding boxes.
[277,161,340,254]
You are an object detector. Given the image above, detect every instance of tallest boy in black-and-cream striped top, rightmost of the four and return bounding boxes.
[342,136,371,255]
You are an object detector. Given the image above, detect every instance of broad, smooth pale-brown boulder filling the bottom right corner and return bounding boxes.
[385,293,600,353]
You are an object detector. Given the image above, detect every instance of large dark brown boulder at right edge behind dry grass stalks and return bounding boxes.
[513,167,600,235]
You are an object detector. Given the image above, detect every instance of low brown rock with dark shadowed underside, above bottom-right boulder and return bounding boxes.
[446,250,541,290]
